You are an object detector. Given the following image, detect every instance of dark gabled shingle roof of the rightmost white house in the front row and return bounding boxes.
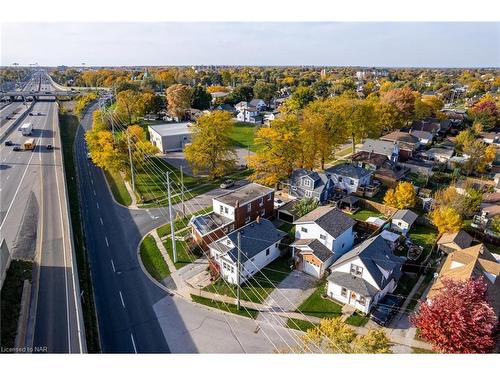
[331,235,403,290]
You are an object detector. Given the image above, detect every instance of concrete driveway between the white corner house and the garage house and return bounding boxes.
[257,270,318,326]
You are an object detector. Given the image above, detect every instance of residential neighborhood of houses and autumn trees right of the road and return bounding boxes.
[1,61,500,353]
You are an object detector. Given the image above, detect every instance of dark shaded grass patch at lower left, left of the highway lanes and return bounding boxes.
[0,260,33,348]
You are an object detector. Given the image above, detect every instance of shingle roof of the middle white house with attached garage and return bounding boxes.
[294,206,356,238]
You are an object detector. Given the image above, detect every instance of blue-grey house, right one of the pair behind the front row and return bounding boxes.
[325,163,373,194]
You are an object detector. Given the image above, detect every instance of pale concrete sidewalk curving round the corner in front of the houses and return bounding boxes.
[146,230,432,350]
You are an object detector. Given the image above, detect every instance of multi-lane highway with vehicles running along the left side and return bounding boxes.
[0,74,86,353]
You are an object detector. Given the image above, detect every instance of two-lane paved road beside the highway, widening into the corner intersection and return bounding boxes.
[75,102,297,353]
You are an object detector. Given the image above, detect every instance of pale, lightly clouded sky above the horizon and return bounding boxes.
[0,22,500,68]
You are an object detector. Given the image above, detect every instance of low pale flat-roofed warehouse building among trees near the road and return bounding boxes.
[148,122,191,153]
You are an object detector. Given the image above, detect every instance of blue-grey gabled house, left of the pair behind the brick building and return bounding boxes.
[282,168,334,204]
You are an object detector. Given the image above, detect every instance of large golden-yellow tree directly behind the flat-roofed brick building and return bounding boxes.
[248,114,301,186]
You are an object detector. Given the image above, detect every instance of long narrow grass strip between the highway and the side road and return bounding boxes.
[59,110,100,353]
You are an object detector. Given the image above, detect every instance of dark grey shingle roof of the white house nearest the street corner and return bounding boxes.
[209,219,286,262]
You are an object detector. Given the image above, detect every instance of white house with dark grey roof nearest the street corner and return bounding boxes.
[208,218,286,284]
